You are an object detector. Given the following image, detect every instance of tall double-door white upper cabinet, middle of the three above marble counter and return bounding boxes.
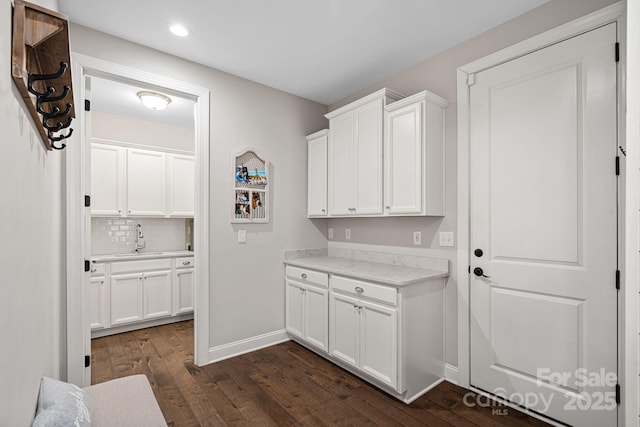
[326,89,402,216]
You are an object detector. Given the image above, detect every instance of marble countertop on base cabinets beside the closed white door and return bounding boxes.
[284,256,449,286]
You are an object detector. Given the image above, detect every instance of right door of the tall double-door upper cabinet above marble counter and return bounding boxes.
[350,99,383,215]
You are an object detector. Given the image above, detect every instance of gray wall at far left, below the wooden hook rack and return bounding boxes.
[0,0,66,427]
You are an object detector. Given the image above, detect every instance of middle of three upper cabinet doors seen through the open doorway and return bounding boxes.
[127,148,167,216]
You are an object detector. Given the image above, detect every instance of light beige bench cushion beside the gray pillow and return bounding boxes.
[84,375,167,427]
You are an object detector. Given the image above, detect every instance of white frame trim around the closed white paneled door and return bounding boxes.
[457,1,624,420]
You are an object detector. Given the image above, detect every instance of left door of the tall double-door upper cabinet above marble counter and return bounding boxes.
[328,112,355,215]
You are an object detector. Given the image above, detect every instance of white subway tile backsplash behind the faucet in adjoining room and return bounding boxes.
[91,217,186,255]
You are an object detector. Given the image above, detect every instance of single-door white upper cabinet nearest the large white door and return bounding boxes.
[384,91,447,216]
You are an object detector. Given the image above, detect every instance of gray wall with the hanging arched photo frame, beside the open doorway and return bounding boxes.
[71,25,327,347]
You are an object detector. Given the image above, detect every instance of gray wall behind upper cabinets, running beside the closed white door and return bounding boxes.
[328,0,615,365]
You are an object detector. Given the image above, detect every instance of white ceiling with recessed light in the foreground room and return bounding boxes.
[59,0,549,121]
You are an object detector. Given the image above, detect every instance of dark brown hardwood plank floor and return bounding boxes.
[91,321,547,427]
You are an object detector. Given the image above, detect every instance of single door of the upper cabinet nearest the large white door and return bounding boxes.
[384,102,424,215]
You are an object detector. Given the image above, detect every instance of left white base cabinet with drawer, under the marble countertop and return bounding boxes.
[285,267,329,352]
